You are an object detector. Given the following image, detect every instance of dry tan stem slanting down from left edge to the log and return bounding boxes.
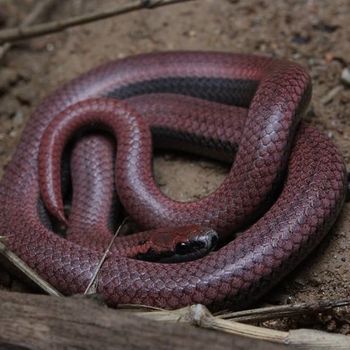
[0,241,63,296]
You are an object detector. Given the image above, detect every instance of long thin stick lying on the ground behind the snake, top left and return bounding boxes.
[0,0,193,43]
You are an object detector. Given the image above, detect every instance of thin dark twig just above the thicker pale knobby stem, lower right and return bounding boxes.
[217,299,350,322]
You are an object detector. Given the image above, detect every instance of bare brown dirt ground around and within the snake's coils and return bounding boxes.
[0,0,350,334]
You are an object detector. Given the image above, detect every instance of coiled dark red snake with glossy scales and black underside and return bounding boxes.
[0,51,347,309]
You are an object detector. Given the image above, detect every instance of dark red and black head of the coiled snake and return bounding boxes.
[137,225,218,263]
